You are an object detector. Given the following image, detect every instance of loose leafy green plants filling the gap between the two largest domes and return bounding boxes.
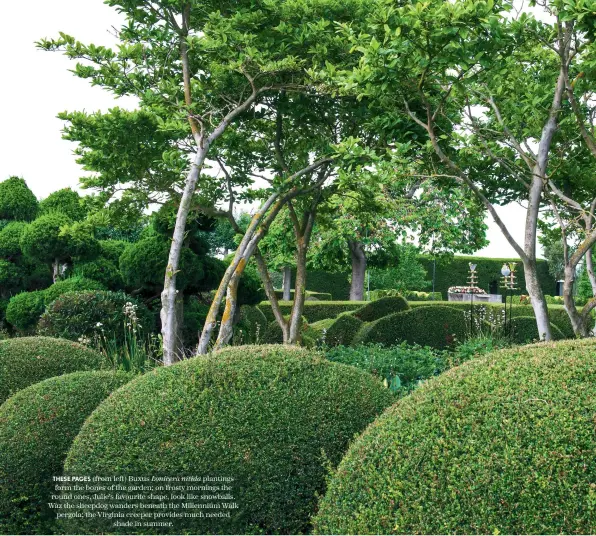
[325,343,446,394]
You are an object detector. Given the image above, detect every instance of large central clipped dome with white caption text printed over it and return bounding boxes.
[65,346,392,534]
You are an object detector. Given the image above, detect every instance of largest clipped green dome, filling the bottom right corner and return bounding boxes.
[314,340,596,534]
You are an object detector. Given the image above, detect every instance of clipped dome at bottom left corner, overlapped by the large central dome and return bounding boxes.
[0,371,131,534]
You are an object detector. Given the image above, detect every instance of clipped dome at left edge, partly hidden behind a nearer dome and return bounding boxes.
[0,337,105,403]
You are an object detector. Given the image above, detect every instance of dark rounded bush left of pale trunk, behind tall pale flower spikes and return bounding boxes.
[38,290,154,341]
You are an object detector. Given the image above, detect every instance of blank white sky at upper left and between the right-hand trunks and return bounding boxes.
[0,0,540,257]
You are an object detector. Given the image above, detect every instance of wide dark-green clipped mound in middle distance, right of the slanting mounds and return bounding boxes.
[361,305,468,348]
